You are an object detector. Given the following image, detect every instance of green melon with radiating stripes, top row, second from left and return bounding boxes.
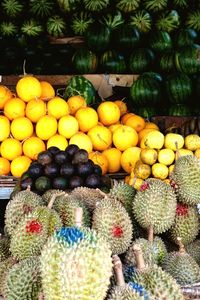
[29,0,54,17]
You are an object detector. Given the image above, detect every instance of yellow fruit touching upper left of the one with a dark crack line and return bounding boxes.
[75,107,98,132]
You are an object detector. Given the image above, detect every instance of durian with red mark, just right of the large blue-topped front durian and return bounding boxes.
[92,197,133,254]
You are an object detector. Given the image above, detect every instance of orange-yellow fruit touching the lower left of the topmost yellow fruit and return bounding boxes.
[3,98,26,120]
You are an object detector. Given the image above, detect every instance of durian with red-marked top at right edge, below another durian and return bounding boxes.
[169,203,200,245]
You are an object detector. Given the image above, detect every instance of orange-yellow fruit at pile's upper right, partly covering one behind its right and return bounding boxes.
[97,101,120,126]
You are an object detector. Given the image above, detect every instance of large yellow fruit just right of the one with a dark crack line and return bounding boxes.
[113,125,138,151]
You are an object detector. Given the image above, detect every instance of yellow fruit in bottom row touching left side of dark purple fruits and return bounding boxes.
[10,155,31,178]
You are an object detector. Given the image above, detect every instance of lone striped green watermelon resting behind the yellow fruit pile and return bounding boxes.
[63,75,96,105]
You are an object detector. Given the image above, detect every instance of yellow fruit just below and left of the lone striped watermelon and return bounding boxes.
[47,96,69,120]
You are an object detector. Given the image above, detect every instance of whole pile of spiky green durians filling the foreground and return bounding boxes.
[0,156,200,300]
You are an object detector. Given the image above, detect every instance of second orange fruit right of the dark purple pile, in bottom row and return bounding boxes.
[103,148,122,173]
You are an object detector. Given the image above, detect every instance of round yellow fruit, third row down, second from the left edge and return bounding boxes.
[10,117,33,141]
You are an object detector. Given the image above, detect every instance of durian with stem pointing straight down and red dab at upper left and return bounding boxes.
[133,178,177,234]
